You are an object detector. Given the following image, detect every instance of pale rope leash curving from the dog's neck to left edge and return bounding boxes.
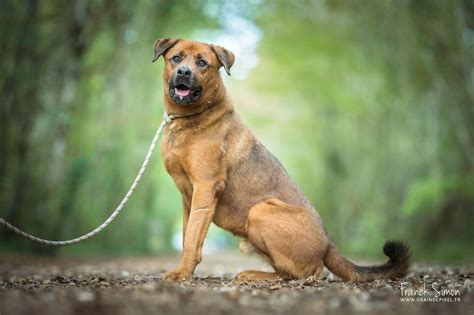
[0,113,178,246]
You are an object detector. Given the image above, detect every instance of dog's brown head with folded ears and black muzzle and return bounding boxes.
[153,38,235,105]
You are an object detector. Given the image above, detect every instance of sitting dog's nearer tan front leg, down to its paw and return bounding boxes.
[165,181,224,282]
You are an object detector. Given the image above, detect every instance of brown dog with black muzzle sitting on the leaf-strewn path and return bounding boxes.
[153,39,410,281]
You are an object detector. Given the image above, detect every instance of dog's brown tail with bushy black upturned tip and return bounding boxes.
[324,241,411,282]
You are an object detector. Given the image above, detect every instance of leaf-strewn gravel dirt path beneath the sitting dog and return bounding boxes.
[0,253,474,315]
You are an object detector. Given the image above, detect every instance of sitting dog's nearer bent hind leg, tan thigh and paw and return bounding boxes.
[237,199,328,281]
